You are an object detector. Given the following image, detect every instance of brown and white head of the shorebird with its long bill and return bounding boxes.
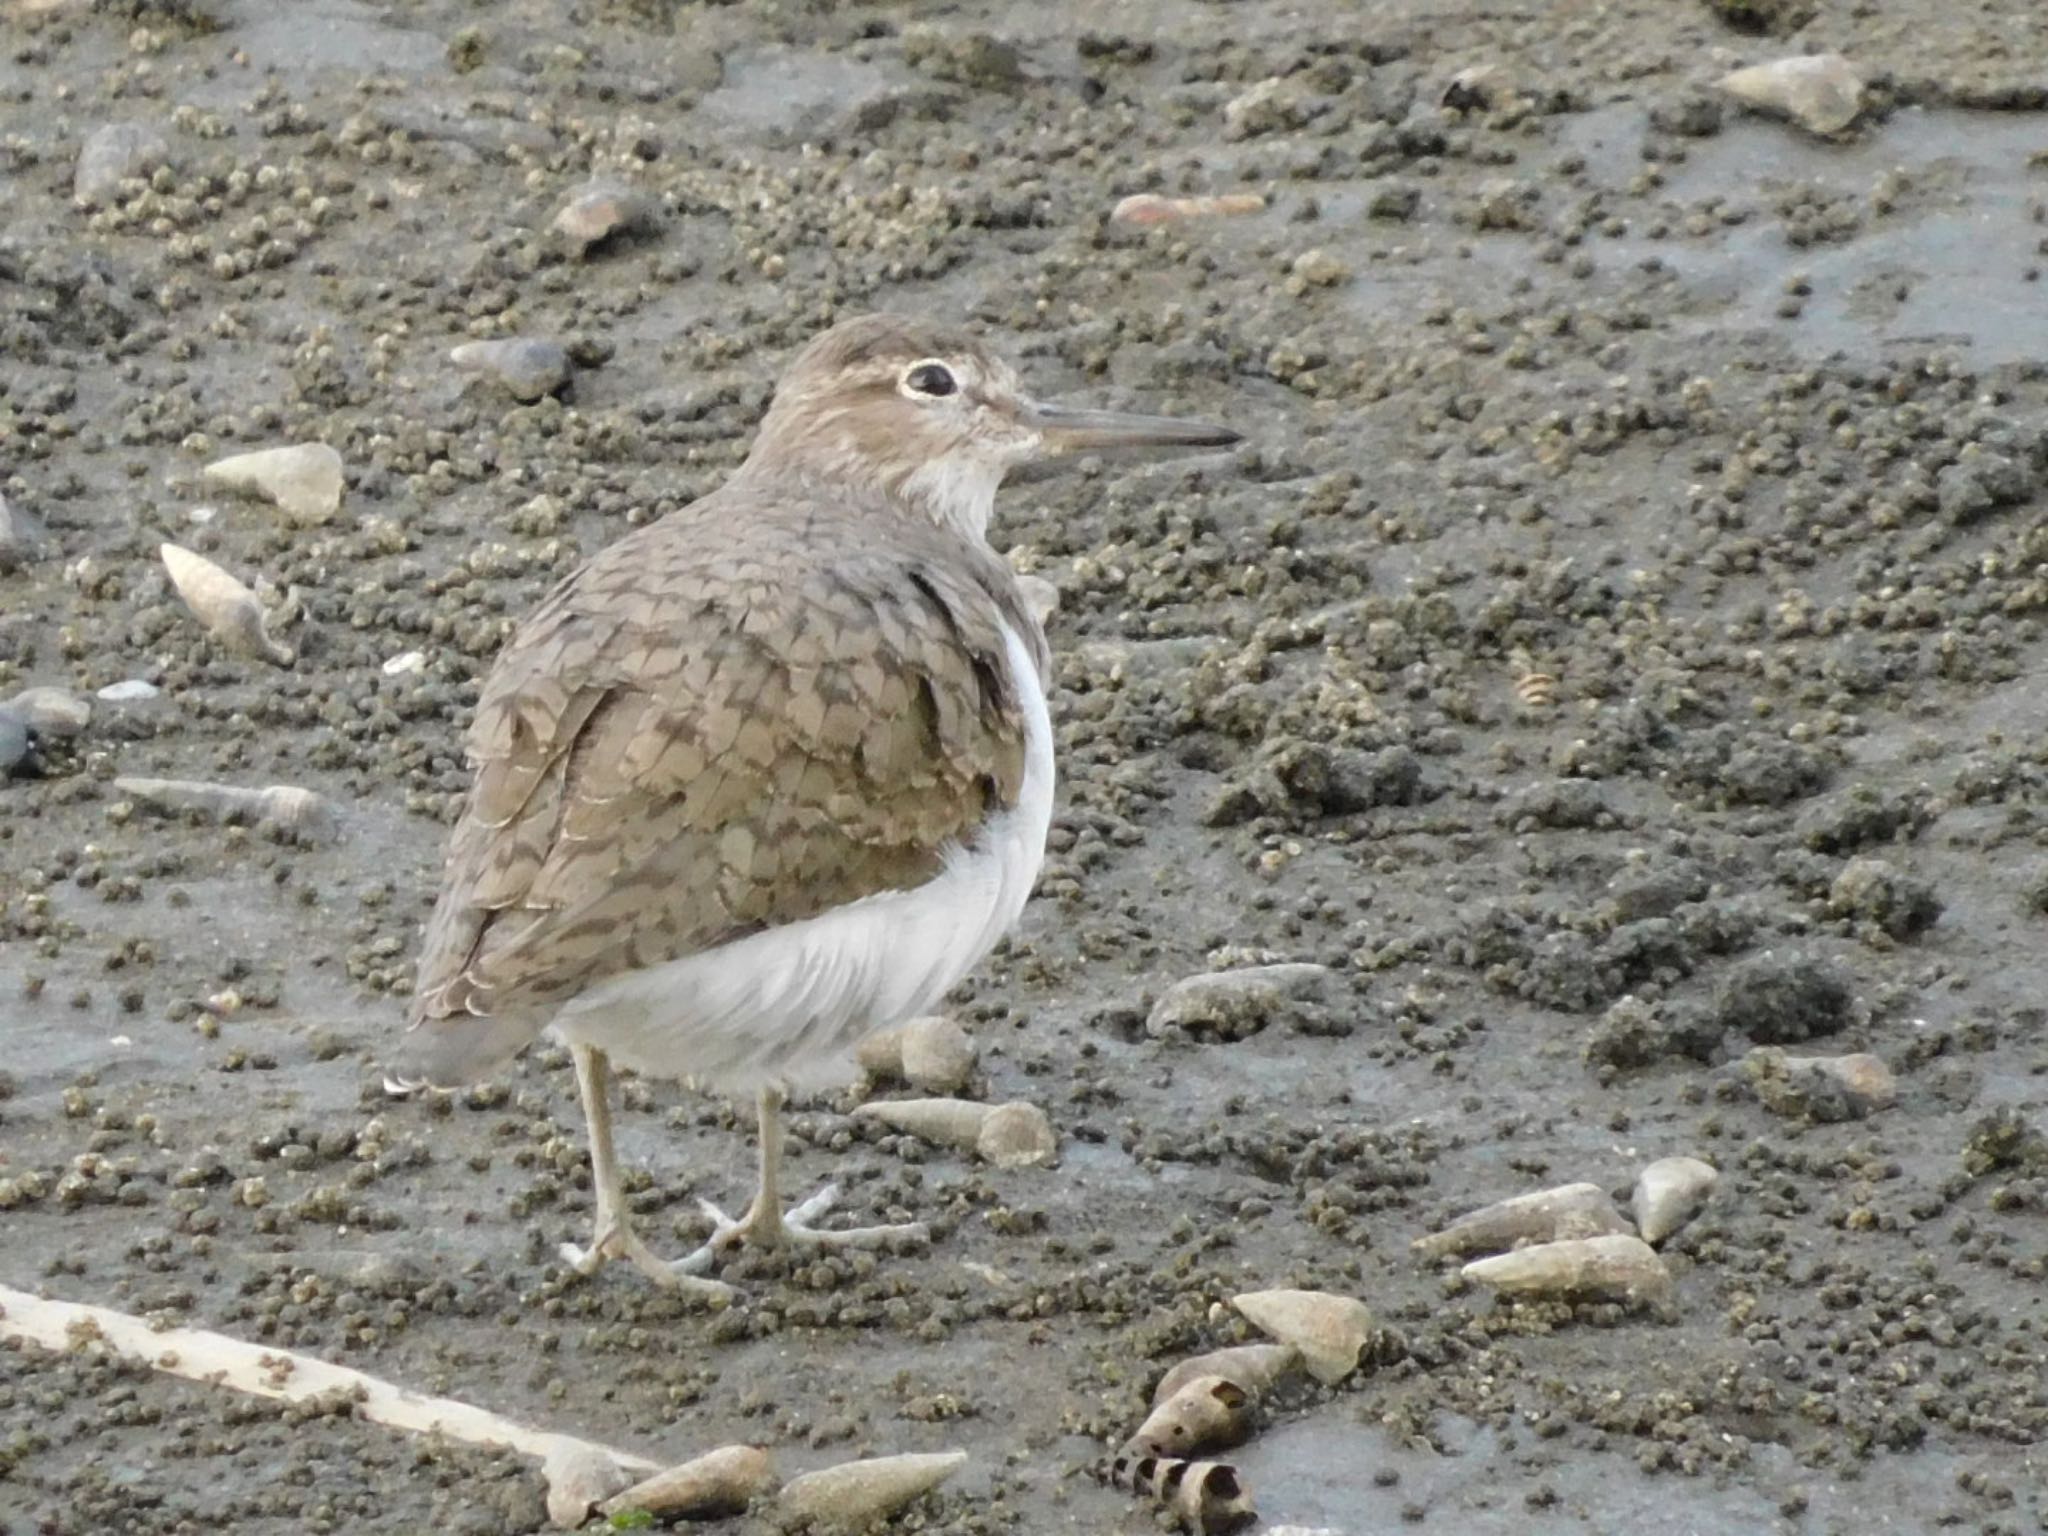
[748,315,1241,539]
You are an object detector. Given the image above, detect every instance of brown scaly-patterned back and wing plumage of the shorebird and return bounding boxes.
[414,494,1044,1081]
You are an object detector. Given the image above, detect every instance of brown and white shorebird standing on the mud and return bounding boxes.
[391,315,1239,1296]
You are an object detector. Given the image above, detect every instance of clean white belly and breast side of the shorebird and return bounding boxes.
[555,627,1053,1094]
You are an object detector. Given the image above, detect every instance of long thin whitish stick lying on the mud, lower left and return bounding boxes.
[0,1286,662,1524]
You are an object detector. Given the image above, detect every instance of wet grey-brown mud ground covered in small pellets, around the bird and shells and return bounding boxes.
[0,0,2048,1536]
